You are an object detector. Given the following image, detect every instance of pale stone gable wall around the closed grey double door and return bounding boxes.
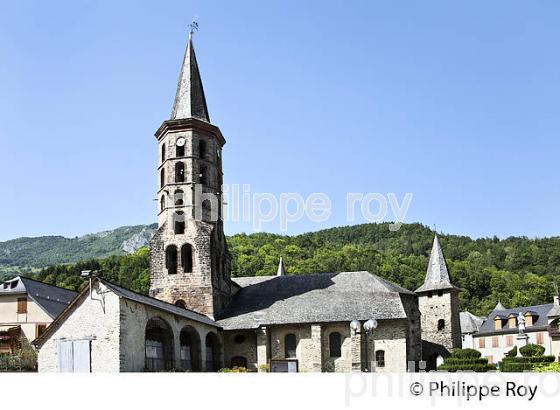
[38,285,120,373]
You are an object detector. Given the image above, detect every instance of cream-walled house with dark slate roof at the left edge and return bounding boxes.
[0,276,77,353]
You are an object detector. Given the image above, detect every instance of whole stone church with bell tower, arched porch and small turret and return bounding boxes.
[34,33,461,372]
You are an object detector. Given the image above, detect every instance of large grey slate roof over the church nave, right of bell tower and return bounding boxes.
[217,271,414,330]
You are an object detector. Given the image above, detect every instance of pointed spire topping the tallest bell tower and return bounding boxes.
[171,30,210,123]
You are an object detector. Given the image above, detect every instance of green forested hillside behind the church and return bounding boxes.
[33,224,560,315]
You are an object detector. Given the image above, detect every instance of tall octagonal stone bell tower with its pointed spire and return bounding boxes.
[150,33,231,317]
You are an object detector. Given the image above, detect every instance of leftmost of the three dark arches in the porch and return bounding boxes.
[144,316,175,372]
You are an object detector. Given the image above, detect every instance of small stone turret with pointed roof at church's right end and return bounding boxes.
[415,235,461,350]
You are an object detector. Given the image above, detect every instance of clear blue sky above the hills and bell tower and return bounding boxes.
[0,0,560,240]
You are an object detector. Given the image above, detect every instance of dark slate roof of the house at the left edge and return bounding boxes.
[0,276,78,319]
